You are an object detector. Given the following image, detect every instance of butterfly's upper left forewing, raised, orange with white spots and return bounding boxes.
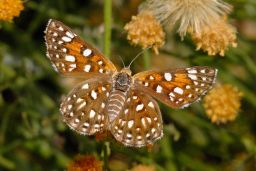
[45,19,116,77]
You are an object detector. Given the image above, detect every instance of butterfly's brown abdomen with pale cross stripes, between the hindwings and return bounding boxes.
[106,89,127,123]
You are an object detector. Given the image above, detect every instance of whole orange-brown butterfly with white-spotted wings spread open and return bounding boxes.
[45,19,217,147]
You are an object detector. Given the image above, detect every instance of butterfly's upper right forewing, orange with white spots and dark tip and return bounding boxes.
[134,66,217,108]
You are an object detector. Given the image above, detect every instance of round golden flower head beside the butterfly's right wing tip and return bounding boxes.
[204,84,243,123]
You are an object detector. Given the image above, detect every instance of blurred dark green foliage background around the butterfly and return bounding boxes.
[0,0,256,171]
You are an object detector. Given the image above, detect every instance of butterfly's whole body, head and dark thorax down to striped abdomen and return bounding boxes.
[107,68,132,123]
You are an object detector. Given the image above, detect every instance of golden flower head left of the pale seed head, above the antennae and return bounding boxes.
[124,11,165,54]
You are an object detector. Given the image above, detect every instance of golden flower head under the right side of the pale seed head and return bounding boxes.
[191,18,237,56]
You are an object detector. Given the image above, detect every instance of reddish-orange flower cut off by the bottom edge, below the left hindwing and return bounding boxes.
[67,155,103,171]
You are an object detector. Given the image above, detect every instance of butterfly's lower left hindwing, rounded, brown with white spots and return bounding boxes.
[60,78,111,135]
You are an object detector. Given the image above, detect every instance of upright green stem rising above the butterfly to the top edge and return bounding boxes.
[104,0,112,58]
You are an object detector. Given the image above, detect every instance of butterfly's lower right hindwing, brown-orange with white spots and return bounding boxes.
[110,90,163,147]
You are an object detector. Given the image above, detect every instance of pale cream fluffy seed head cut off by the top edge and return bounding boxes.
[140,0,231,38]
